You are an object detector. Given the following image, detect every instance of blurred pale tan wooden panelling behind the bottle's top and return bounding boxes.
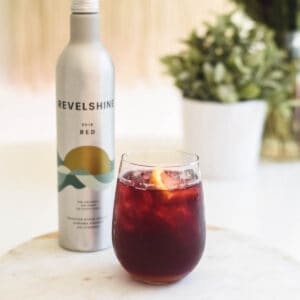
[0,0,230,88]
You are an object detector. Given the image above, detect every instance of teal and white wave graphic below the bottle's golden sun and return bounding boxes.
[57,149,115,192]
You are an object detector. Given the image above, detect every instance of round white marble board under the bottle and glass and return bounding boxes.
[0,228,300,300]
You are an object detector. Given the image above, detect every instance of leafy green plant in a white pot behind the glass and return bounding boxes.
[162,11,289,178]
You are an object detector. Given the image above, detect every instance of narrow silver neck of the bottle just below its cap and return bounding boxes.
[71,13,100,43]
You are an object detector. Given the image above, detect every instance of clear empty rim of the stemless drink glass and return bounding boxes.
[121,150,200,169]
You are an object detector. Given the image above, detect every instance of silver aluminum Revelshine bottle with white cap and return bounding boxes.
[56,0,115,252]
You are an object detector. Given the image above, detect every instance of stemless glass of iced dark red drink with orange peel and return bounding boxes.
[112,152,205,284]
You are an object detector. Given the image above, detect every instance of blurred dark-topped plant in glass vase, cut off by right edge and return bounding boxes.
[234,0,300,159]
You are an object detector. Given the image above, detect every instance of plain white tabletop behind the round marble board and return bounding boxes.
[0,140,300,261]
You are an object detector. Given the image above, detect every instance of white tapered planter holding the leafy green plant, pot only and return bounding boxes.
[183,99,267,179]
